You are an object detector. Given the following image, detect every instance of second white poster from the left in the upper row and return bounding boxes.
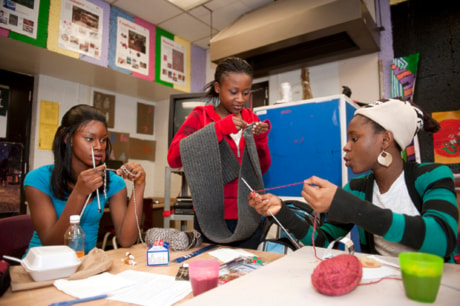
[58,0,103,59]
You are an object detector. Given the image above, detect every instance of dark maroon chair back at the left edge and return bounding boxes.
[0,215,34,259]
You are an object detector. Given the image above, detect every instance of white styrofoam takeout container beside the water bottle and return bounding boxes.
[22,245,81,282]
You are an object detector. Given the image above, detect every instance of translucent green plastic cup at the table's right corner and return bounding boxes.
[399,252,444,303]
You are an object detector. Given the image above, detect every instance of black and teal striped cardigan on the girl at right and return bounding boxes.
[277,163,458,262]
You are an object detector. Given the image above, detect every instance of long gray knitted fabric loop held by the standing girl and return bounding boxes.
[180,123,263,243]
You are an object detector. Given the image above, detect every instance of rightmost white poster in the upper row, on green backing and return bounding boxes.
[160,36,187,86]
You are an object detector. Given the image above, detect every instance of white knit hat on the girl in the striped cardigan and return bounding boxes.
[355,99,423,150]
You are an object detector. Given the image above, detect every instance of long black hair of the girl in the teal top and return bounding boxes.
[51,104,112,200]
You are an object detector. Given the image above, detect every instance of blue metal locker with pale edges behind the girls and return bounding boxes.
[254,95,358,197]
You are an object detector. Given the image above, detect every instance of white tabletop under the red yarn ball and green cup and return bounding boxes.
[181,246,460,306]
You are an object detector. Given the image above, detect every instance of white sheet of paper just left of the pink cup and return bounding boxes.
[108,270,192,306]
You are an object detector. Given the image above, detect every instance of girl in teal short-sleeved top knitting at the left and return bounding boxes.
[24,104,145,254]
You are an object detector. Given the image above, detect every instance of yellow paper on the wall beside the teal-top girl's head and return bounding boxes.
[38,100,59,150]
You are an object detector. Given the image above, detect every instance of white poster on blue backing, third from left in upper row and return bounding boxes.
[115,17,150,75]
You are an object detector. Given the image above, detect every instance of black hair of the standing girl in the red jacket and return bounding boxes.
[203,56,254,101]
